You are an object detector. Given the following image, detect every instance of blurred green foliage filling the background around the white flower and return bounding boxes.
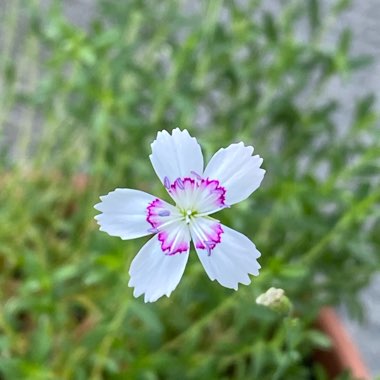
[0,0,380,380]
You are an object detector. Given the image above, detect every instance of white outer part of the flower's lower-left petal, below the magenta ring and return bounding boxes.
[128,236,189,302]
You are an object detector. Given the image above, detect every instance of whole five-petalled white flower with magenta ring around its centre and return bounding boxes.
[95,128,265,302]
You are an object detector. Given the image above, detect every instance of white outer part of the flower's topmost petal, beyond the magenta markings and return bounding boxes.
[149,128,203,184]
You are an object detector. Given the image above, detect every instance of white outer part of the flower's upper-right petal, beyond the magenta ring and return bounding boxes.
[203,142,265,205]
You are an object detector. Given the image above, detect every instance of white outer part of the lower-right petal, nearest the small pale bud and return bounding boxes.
[196,225,260,290]
